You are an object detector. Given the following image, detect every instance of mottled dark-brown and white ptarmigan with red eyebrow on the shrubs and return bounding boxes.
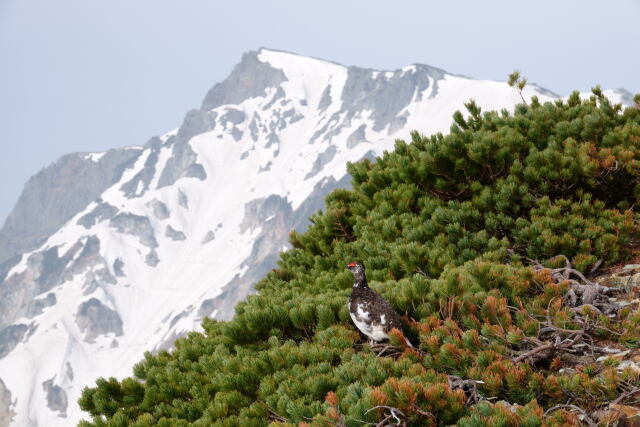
[347,262,413,347]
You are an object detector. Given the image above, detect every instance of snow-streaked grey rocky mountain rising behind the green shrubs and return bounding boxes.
[0,49,630,426]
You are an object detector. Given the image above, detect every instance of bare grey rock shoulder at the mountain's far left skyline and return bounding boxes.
[0,149,141,263]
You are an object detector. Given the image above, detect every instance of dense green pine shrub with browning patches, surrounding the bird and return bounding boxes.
[79,89,640,426]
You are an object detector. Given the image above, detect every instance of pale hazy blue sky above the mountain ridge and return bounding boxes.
[0,0,640,224]
